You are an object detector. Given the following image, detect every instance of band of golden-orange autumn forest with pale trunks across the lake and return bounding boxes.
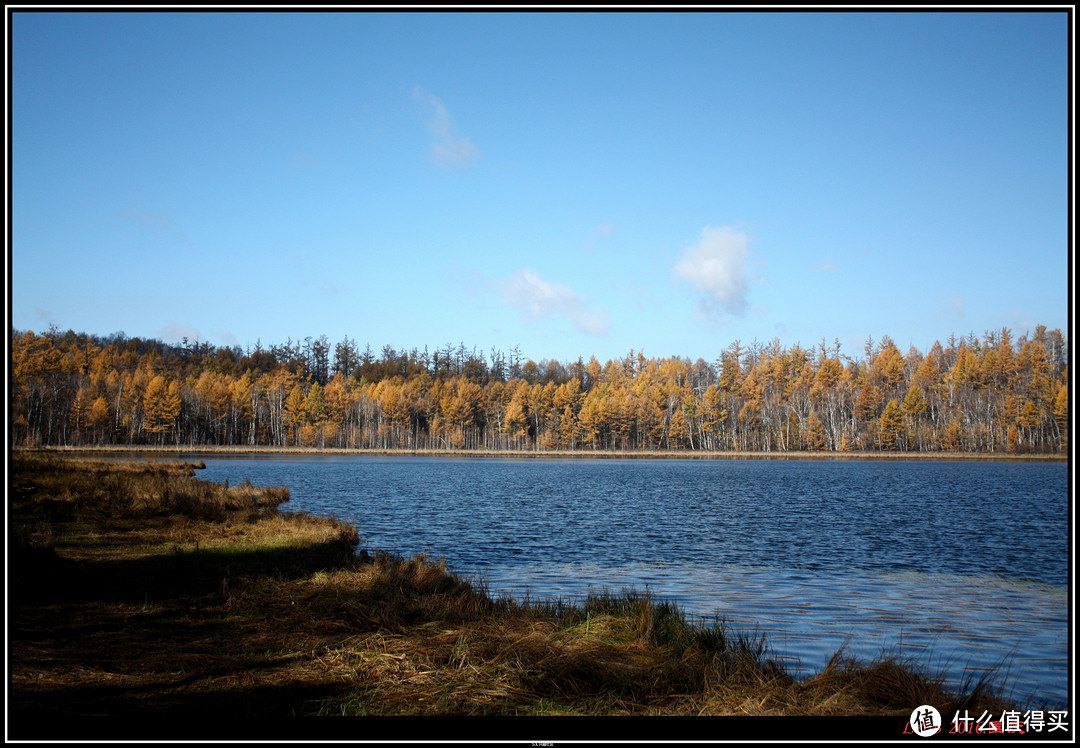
[10,326,1069,454]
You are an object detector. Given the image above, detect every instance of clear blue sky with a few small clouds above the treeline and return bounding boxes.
[9,11,1070,362]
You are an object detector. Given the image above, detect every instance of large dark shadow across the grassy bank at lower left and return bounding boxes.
[8,533,375,739]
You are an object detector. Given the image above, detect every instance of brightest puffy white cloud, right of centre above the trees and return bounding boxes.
[672,226,750,317]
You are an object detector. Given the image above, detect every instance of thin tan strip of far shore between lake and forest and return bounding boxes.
[12,445,1069,462]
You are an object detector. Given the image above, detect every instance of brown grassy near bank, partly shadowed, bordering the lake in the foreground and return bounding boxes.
[8,451,1009,739]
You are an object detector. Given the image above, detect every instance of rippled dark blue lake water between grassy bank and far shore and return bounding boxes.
[190,455,1069,706]
